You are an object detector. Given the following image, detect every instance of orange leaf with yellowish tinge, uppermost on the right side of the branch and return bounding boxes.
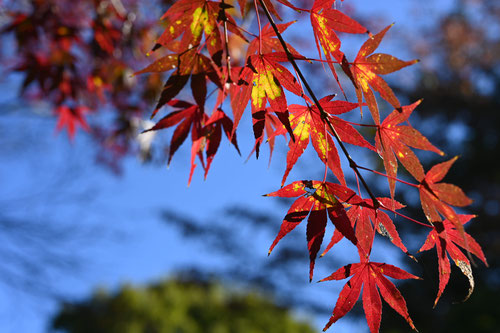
[351,24,418,125]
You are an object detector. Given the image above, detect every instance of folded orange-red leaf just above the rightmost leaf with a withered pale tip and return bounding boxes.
[418,156,472,241]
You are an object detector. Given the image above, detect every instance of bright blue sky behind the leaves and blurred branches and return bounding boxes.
[0,0,458,333]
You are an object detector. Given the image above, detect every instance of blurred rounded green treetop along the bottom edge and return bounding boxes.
[53,279,315,333]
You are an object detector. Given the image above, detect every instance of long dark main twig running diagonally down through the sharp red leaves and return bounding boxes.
[254,0,380,208]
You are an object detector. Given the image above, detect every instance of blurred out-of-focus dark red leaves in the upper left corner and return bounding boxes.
[0,0,170,170]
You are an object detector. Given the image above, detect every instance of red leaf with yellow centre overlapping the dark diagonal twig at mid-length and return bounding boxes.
[276,95,374,186]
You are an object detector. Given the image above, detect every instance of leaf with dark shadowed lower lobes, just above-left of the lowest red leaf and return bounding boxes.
[264,180,357,280]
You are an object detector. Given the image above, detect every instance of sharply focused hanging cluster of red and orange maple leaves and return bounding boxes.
[131,0,486,332]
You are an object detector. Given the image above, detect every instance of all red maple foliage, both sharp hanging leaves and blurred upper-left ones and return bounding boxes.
[3,0,487,332]
